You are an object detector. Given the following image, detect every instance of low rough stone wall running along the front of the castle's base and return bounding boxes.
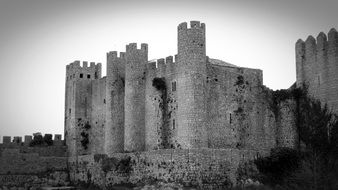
[69,149,268,189]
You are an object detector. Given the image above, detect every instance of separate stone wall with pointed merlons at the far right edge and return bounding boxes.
[296,29,338,112]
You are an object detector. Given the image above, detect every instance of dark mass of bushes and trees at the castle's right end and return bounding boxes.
[247,88,338,190]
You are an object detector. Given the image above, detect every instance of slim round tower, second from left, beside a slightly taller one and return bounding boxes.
[104,51,126,154]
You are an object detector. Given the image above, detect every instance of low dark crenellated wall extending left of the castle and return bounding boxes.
[0,135,70,189]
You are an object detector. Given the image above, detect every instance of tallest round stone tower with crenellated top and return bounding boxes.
[177,21,208,148]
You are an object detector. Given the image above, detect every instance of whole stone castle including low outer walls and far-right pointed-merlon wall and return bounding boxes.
[0,21,338,189]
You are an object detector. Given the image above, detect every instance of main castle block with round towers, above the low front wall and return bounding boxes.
[65,21,295,156]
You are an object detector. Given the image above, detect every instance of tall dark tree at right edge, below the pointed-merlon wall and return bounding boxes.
[294,96,338,189]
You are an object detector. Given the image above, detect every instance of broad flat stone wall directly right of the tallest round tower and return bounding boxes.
[207,64,275,149]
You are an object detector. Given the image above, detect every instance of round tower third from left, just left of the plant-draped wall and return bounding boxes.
[124,43,148,151]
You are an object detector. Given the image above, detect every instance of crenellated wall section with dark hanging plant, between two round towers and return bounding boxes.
[145,56,178,150]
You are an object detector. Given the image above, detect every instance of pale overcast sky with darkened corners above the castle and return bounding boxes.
[0,0,338,138]
